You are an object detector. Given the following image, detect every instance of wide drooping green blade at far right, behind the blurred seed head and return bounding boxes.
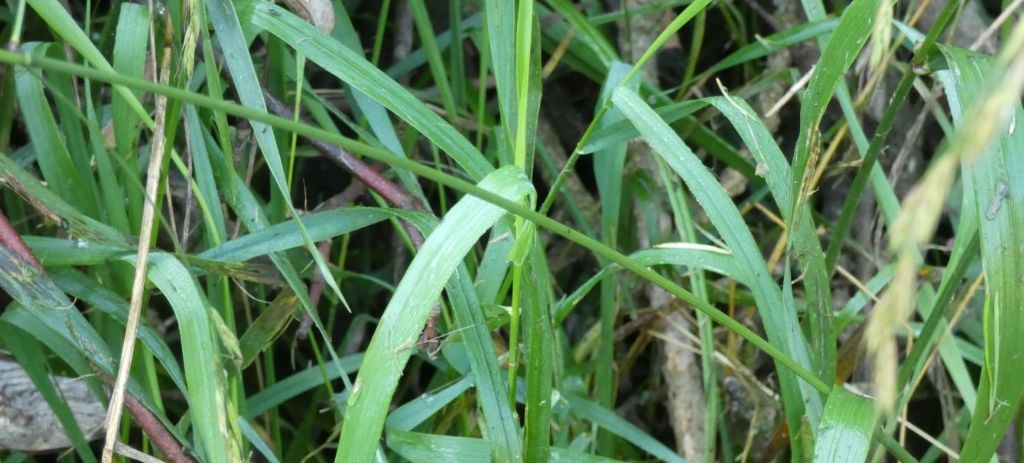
[940,42,1024,461]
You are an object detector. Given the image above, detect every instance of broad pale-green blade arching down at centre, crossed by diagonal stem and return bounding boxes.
[336,168,532,461]
